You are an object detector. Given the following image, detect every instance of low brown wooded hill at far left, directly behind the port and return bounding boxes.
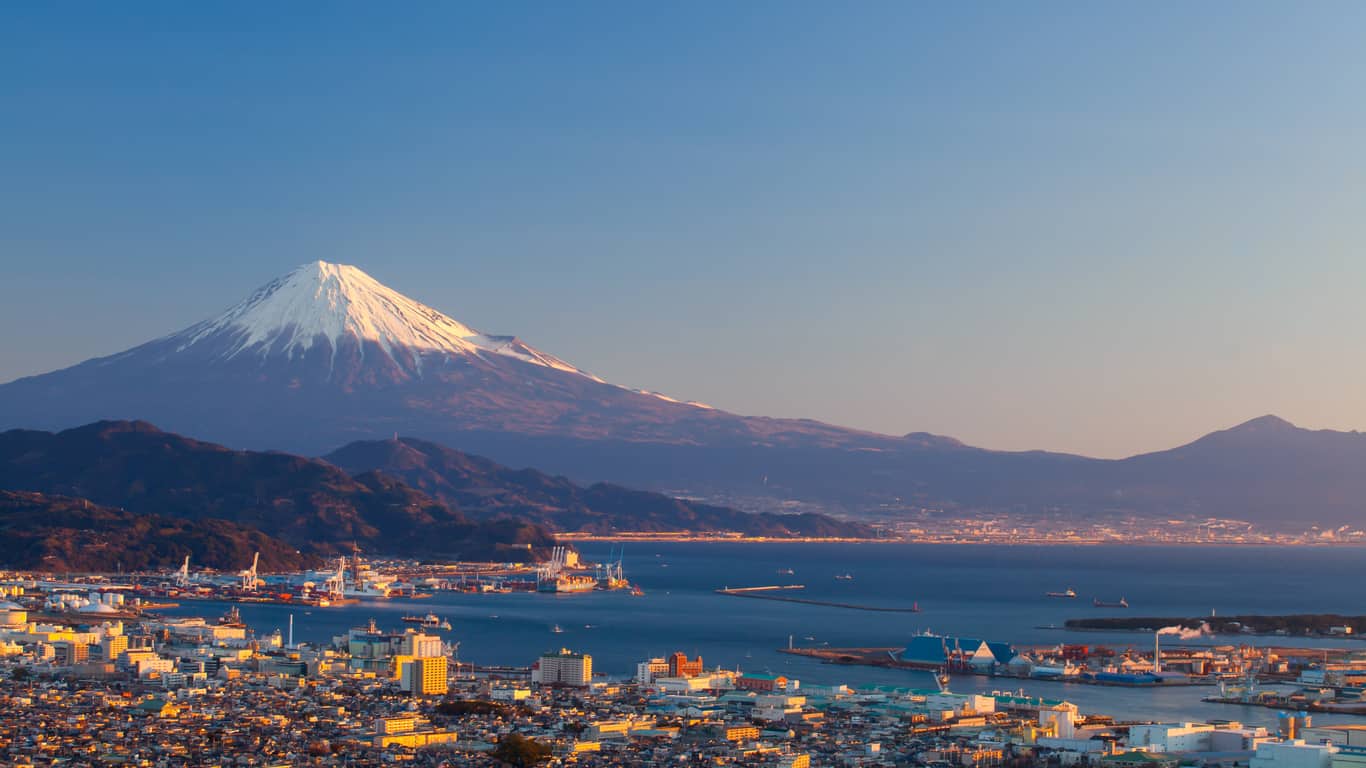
[0,491,312,573]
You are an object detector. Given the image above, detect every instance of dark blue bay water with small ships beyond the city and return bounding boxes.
[162,544,1366,723]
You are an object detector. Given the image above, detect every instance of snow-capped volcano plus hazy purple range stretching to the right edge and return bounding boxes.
[0,262,1366,526]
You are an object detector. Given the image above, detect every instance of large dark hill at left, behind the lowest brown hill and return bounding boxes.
[0,421,553,567]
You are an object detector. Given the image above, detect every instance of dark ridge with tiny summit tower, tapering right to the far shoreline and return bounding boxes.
[324,437,877,538]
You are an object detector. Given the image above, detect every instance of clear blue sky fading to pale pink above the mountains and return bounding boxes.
[0,0,1366,456]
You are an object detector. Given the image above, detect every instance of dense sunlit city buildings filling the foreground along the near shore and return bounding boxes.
[0,575,1366,768]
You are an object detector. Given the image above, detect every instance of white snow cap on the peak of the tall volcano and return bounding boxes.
[173,261,601,381]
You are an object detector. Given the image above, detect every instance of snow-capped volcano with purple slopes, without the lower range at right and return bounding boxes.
[0,261,893,481]
